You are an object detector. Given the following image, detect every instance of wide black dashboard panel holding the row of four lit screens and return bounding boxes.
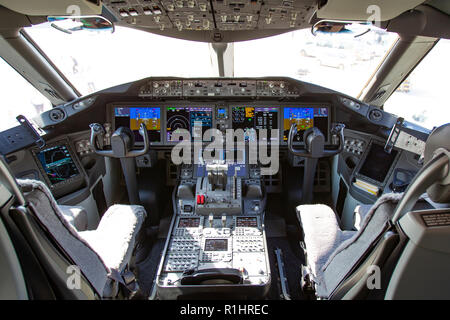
[107,101,332,146]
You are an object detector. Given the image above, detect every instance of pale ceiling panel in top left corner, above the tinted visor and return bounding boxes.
[0,0,102,16]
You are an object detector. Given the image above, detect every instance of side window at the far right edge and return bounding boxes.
[384,39,450,129]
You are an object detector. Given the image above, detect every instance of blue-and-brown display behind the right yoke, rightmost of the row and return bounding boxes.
[283,107,328,142]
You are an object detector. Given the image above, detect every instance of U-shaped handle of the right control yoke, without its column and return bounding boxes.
[288,123,345,159]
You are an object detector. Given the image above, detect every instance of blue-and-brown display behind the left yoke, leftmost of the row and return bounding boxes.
[114,107,161,142]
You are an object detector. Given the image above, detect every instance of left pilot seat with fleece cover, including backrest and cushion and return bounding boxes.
[0,162,147,299]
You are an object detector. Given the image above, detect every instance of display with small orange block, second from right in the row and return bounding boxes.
[232,107,278,141]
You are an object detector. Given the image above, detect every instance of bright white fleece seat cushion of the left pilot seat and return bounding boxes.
[79,205,146,272]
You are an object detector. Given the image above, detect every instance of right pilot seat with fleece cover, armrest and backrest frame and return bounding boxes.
[296,124,450,299]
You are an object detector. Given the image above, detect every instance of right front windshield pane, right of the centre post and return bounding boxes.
[234,29,397,97]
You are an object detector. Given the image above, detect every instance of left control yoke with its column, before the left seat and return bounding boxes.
[89,123,149,204]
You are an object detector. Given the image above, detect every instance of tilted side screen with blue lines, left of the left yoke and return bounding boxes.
[36,144,80,185]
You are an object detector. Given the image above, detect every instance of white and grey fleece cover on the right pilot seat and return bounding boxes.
[297,193,403,298]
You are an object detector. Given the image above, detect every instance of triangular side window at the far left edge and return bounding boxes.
[0,58,52,131]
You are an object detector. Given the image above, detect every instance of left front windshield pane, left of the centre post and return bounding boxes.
[26,23,218,95]
